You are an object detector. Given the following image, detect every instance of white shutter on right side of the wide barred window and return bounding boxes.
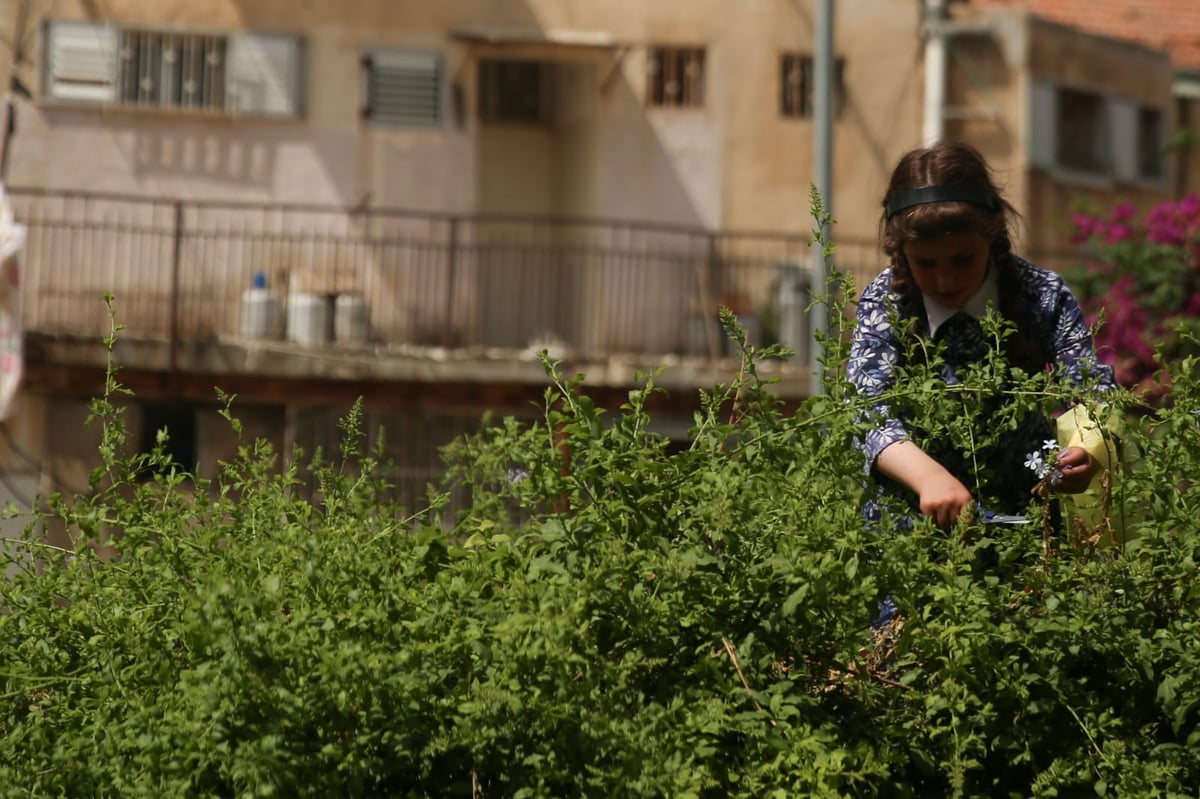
[229,34,300,116]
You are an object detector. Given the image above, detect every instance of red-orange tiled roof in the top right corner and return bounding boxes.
[971,0,1200,70]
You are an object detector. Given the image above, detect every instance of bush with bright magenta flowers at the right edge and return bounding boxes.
[1068,194,1200,396]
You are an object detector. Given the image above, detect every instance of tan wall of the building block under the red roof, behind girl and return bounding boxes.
[946,8,1177,263]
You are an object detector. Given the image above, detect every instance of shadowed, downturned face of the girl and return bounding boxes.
[904,233,991,308]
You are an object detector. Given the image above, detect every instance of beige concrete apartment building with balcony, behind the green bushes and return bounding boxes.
[0,0,1176,535]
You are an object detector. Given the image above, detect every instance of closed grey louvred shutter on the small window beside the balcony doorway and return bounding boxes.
[366,50,444,127]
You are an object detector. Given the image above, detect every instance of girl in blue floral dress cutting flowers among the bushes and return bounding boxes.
[847,142,1114,528]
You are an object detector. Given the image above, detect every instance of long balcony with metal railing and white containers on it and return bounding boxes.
[10,190,878,396]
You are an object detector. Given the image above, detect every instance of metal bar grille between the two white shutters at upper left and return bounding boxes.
[116,30,229,110]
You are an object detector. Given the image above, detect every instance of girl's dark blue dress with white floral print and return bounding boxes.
[847,257,1114,513]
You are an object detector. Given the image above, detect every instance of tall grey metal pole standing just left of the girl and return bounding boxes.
[809,0,834,396]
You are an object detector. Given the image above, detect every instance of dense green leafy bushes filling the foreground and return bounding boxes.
[0,233,1200,799]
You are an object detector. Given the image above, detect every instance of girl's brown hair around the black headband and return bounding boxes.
[880,142,1018,316]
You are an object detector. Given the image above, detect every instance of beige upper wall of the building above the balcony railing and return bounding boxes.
[0,0,920,242]
